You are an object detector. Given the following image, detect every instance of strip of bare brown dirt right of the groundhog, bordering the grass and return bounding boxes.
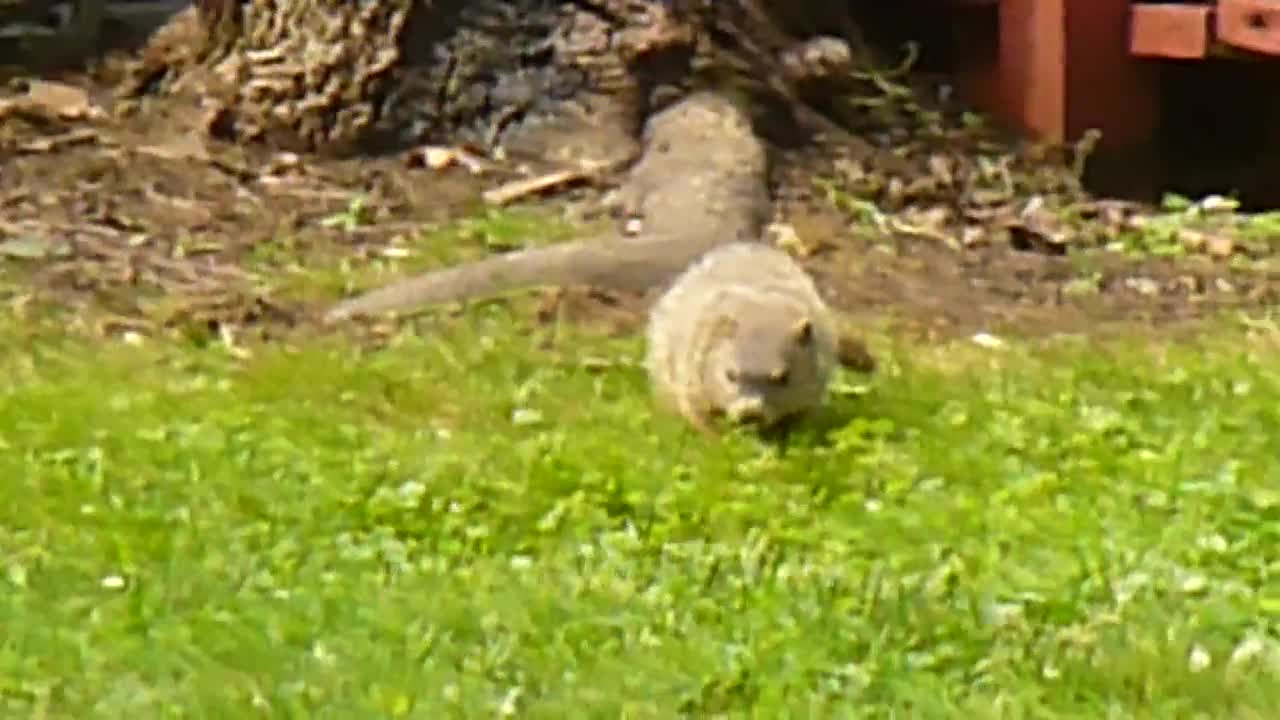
[813,224,1280,340]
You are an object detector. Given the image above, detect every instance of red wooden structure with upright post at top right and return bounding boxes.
[943,0,1280,146]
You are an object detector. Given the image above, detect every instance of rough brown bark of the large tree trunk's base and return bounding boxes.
[120,0,875,152]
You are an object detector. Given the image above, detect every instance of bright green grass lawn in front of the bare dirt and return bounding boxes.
[0,306,1280,720]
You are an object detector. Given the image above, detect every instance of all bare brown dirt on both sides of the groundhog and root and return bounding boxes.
[0,48,1280,348]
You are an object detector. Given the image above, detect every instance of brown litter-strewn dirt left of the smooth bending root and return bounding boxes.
[0,58,494,327]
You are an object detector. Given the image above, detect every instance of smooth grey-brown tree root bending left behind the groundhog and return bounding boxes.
[324,91,771,323]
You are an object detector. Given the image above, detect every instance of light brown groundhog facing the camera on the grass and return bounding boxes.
[646,242,838,432]
